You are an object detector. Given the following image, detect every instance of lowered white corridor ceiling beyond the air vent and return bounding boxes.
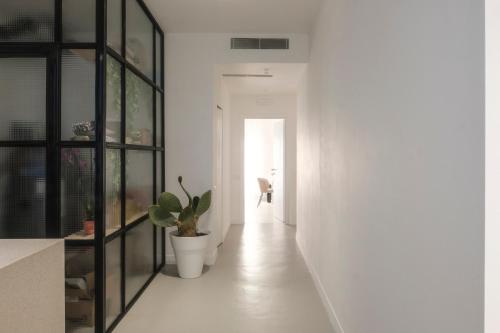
[221,64,306,95]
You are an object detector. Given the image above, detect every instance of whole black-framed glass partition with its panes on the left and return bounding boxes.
[0,0,165,333]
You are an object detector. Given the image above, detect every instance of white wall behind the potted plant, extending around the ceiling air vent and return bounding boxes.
[165,33,309,263]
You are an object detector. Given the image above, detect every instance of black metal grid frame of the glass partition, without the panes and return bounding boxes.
[0,0,165,333]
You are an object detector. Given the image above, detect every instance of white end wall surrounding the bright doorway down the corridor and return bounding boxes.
[229,94,297,224]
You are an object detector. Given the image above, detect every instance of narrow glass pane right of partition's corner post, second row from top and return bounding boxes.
[106,56,122,142]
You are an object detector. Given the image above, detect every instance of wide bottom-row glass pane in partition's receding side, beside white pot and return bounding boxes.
[125,220,154,304]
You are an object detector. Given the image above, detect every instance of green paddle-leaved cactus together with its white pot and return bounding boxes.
[149,177,212,279]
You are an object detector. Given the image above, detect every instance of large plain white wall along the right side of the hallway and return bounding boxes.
[297,0,484,333]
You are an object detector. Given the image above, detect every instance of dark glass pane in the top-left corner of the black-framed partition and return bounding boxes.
[0,0,55,42]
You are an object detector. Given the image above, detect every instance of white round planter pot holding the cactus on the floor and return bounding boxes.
[170,231,210,279]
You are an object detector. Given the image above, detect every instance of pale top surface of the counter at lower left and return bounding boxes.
[0,239,64,269]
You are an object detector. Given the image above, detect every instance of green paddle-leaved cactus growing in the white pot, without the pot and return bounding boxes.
[148,177,212,237]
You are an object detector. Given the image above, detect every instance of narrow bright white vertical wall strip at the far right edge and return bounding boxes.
[485,0,500,333]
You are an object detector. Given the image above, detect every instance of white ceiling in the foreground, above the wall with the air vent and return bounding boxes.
[145,0,323,34]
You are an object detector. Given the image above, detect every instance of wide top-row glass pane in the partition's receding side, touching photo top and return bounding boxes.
[126,0,153,80]
